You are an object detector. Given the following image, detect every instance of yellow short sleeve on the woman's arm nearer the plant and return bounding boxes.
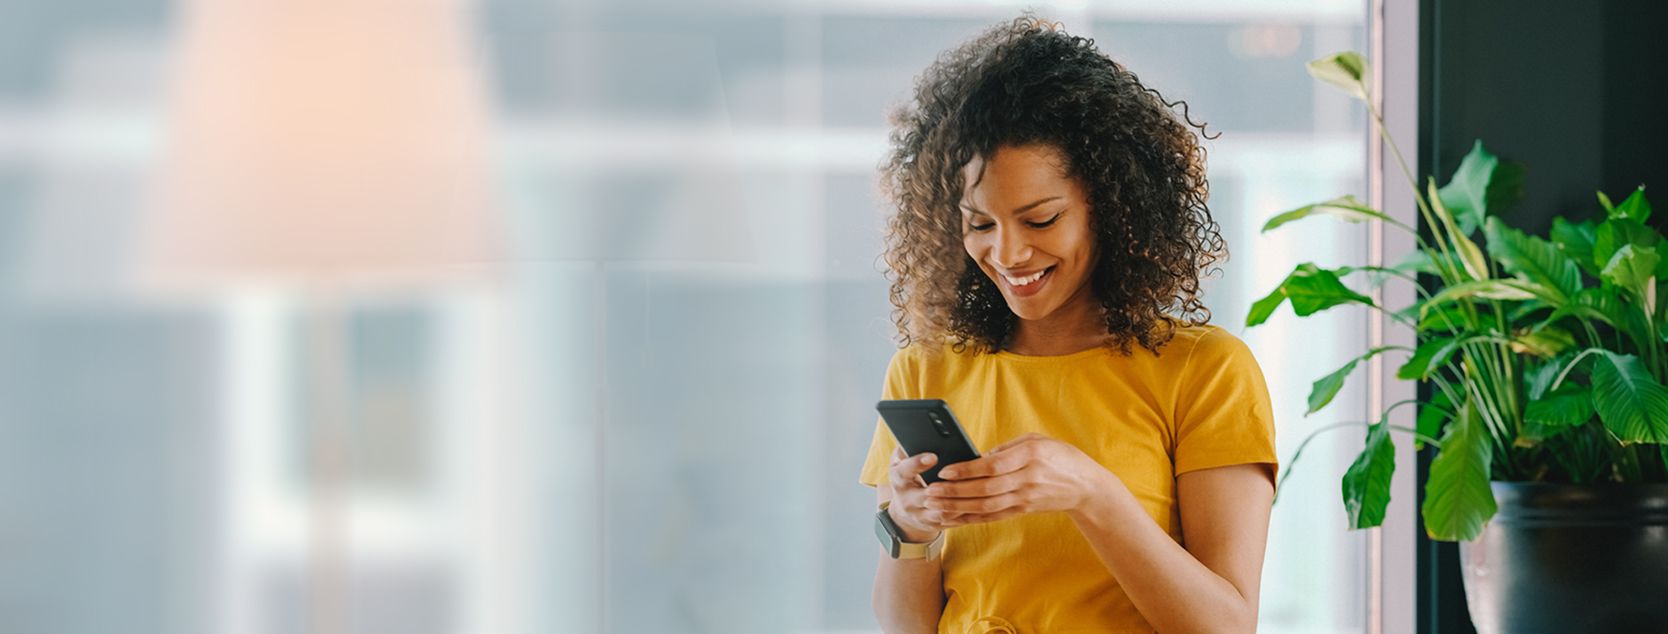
[1174,327,1279,476]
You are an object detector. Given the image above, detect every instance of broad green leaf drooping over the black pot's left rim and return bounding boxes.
[1419,402,1498,542]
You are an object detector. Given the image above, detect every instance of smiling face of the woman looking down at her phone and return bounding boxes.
[961,145,1096,320]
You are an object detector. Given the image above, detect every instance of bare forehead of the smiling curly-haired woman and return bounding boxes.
[962,145,1079,210]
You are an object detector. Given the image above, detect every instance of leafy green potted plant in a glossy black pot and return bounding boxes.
[1246,53,1668,632]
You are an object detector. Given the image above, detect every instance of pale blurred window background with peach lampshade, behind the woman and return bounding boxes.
[0,0,1366,634]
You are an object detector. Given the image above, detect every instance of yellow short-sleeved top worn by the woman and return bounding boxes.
[859,325,1276,634]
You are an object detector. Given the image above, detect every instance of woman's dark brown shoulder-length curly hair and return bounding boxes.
[881,13,1228,355]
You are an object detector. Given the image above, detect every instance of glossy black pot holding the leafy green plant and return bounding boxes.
[1460,482,1668,634]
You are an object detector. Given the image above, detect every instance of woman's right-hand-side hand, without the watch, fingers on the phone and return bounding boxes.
[926,434,1116,527]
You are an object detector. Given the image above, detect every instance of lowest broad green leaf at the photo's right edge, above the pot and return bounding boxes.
[1593,350,1668,444]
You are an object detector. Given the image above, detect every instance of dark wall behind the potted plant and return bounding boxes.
[1418,0,1668,634]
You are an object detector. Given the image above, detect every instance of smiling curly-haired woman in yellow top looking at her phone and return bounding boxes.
[861,17,1274,632]
